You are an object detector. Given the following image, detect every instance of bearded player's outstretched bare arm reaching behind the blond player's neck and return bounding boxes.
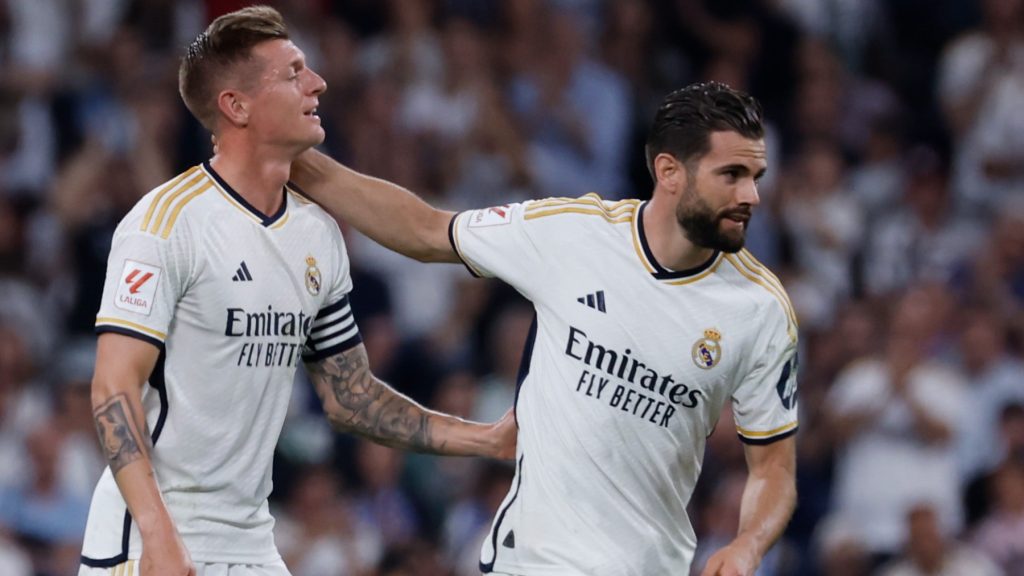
[292,150,460,262]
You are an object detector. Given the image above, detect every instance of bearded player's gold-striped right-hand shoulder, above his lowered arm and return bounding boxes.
[717,249,799,340]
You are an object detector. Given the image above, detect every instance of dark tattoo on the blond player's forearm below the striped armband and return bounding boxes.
[306,344,446,453]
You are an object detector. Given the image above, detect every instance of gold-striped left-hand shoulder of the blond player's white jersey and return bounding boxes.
[118,165,216,240]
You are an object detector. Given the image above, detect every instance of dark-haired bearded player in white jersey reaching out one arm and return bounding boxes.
[293,83,797,576]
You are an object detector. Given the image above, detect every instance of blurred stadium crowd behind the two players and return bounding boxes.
[0,0,1024,576]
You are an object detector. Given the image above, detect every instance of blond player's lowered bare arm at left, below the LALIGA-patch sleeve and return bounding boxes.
[92,332,196,576]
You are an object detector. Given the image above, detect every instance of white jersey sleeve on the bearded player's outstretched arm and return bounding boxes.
[449,204,543,292]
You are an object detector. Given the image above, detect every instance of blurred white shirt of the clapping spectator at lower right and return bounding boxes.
[827,360,968,553]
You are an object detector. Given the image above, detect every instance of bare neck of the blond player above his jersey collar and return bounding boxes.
[210,138,294,214]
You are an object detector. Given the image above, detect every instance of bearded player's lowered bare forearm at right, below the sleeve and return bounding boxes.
[701,436,797,576]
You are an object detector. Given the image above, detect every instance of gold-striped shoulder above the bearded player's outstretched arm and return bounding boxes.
[522,193,641,228]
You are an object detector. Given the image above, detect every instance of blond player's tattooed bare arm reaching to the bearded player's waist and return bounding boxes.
[306,344,516,459]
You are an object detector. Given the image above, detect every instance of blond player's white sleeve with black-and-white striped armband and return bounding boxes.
[302,218,362,362]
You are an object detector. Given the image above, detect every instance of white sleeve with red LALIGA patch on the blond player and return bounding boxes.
[96,219,195,347]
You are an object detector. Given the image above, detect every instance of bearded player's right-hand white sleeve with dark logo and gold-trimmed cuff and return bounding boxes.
[732,307,798,444]
